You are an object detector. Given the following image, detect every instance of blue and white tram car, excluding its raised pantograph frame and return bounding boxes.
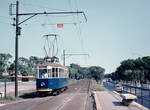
[36,57,69,94]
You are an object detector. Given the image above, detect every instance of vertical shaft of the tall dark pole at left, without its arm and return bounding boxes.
[15,1,19,97]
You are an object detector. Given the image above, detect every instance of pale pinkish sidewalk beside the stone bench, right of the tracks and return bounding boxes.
[94,91,148,110]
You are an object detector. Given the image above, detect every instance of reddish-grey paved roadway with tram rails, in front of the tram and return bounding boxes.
[0,79,93,110]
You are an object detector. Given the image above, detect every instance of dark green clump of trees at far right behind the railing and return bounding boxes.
[113,56,150,82]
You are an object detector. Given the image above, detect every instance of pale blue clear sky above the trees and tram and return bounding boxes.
[0,0,150,73]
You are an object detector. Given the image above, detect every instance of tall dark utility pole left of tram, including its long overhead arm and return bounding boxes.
[10,0,87,97]
